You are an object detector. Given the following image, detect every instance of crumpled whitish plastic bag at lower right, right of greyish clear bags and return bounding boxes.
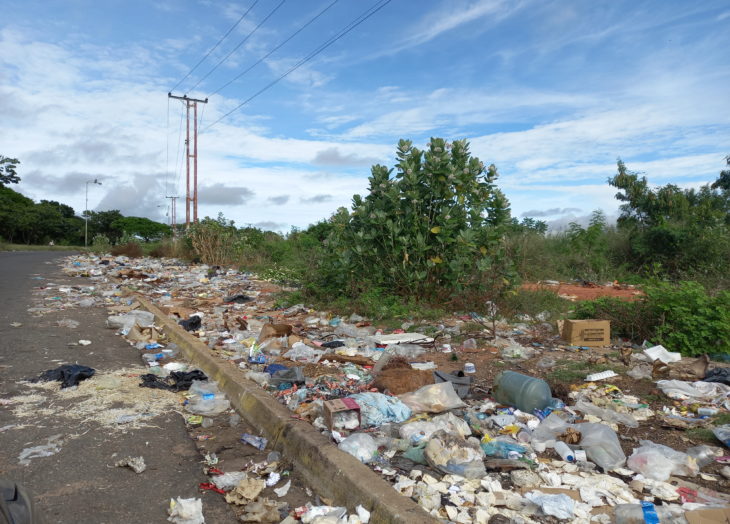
[626,440,699,481]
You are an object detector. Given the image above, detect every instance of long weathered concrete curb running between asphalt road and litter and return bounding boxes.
[137,295,439,524]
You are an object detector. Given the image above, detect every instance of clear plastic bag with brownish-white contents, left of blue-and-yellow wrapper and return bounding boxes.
[424,430,487,479]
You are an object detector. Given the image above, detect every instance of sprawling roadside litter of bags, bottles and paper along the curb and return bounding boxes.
[59,256,730,522]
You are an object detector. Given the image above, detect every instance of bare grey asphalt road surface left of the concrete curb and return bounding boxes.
[0,252,237,524]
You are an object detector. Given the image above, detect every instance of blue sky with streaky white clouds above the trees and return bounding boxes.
[0,0,730,232]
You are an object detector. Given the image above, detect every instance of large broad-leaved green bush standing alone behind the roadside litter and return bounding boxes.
[310,138,514,300]
